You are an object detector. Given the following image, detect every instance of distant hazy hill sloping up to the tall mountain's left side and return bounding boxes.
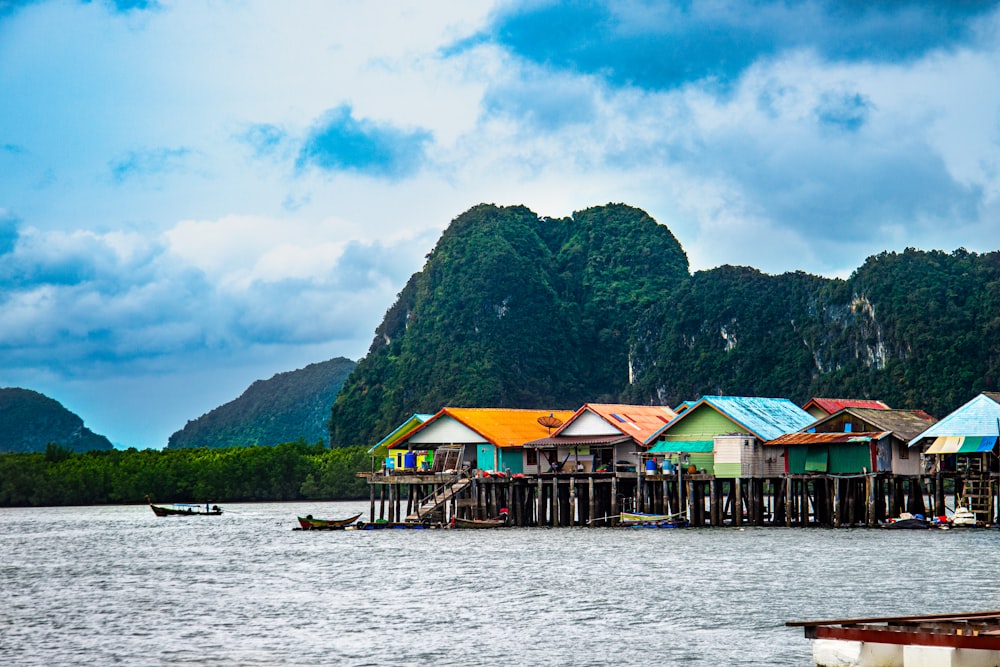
[167,357,355,449]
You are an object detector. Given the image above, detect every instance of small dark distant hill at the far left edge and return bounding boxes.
[0,387,113,453]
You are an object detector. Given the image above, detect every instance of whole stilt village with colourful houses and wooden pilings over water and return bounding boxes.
[358,393,1000,528]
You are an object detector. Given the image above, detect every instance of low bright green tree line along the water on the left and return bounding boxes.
[0,440,370,507]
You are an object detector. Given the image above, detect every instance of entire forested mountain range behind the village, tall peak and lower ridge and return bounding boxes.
[330,204,1000,446]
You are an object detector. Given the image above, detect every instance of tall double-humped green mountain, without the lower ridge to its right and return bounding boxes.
[330,204,688,446]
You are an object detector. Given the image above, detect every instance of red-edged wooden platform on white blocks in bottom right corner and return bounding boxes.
[786,611,1000,667]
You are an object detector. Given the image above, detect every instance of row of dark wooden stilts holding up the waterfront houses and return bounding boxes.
[358,467,1000,527]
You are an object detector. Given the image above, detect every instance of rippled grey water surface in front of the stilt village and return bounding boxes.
[0,503,1000,667]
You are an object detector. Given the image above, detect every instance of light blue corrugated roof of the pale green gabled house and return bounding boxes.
[646,396,815,444]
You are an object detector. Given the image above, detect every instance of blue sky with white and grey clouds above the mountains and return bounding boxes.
[0,0,1000,449]
